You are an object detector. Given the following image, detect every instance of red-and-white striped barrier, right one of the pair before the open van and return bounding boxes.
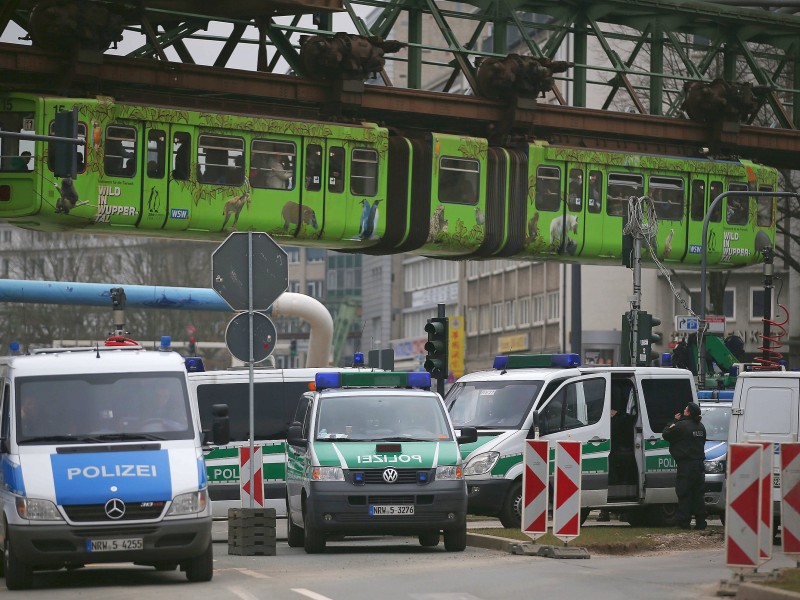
[553,440,581,542]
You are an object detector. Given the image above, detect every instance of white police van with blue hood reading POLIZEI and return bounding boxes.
[0,341,222,590]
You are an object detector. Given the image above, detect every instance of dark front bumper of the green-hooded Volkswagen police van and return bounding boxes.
[306,481,467,535]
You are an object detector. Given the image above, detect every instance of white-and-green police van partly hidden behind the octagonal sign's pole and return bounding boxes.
[186,357,380,518]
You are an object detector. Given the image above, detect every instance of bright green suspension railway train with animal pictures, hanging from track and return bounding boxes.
[0,93,778,269]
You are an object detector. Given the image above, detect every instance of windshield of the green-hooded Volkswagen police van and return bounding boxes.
[316,394,453,442]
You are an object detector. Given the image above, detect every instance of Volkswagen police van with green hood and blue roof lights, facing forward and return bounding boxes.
[286,371,477,553]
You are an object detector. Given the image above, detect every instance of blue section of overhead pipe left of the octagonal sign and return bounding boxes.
[0,279,233,312]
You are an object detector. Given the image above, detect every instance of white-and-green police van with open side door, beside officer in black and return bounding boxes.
[445,354,697,528]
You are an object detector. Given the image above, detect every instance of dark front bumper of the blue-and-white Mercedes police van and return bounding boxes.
[8,515,211,569]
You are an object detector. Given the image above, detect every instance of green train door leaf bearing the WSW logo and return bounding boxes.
[161,125,196,230]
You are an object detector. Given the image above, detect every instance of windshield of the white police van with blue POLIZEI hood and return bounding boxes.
[15,373,194,444]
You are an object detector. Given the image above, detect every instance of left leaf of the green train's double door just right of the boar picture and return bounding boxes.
[294,138,328,240]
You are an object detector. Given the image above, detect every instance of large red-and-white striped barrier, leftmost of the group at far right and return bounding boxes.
[725,444,763,569]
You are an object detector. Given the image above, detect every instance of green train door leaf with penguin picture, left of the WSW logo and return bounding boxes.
[139,125,168,229]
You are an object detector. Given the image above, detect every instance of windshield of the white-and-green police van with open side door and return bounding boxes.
[445,381,542,429]
